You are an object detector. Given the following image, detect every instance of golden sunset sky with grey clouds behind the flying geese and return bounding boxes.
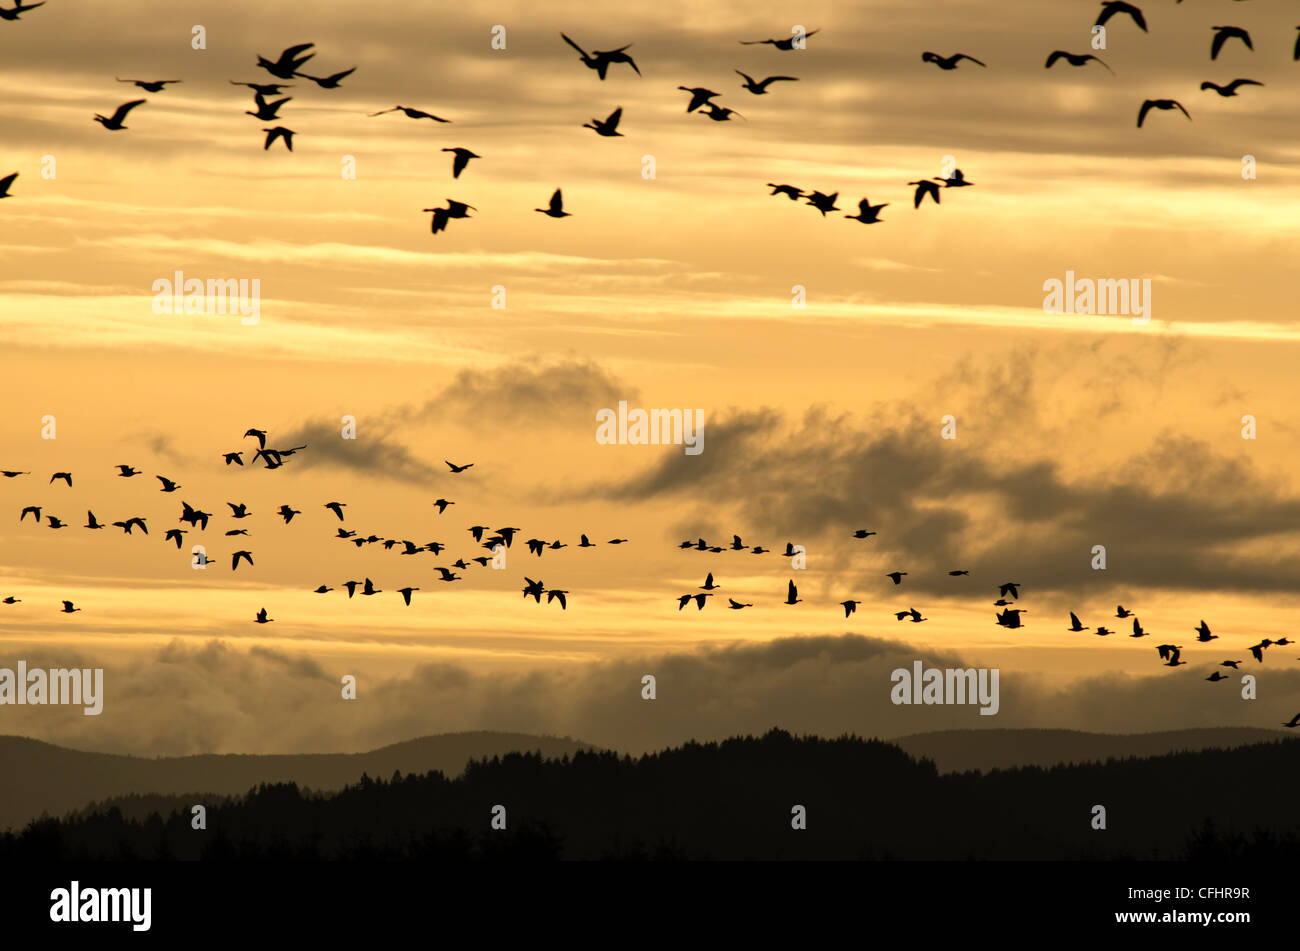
[0,0,1300,755]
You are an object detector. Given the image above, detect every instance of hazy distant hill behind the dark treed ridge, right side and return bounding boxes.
[889,726,1300,773]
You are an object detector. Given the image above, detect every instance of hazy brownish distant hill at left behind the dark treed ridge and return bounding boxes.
[0,731,597,831]
